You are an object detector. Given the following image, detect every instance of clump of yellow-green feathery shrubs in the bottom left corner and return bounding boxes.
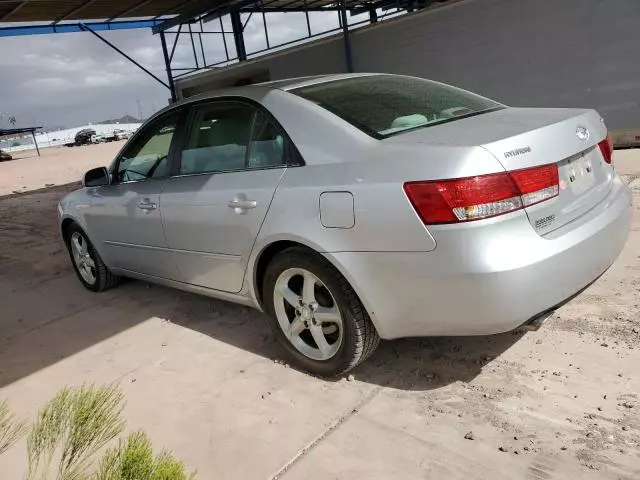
[0,385,195,480]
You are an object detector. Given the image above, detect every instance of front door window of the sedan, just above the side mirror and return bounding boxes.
[116,112,180,182]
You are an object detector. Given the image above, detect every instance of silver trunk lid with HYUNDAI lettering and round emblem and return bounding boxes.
[385,108,614,235]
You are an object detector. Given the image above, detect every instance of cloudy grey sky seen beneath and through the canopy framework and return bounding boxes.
[0,12,350,128]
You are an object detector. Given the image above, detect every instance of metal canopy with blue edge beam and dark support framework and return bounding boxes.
[0,0,450,105]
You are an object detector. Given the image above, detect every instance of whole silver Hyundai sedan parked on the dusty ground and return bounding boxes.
[59,74,631,375]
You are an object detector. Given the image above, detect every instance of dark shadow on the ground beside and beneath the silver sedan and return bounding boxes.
[0,184,523,390]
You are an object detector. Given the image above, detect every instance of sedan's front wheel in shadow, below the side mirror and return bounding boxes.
[65,223,121,292]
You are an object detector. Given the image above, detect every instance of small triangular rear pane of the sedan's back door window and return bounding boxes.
[249,112,285,168]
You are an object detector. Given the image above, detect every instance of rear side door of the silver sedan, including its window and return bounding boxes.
[161,100,292,292]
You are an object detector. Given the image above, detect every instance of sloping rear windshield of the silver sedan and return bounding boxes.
[290,75,503,138]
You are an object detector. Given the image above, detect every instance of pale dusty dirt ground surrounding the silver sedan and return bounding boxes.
[0,145,640,480]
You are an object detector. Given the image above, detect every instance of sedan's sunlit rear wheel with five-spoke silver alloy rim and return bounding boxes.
[263,247,380,376]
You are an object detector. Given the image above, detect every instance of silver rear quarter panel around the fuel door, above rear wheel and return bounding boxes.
[254,90,504,252]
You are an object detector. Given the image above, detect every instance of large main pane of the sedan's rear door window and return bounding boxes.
[180,103,255,175]
